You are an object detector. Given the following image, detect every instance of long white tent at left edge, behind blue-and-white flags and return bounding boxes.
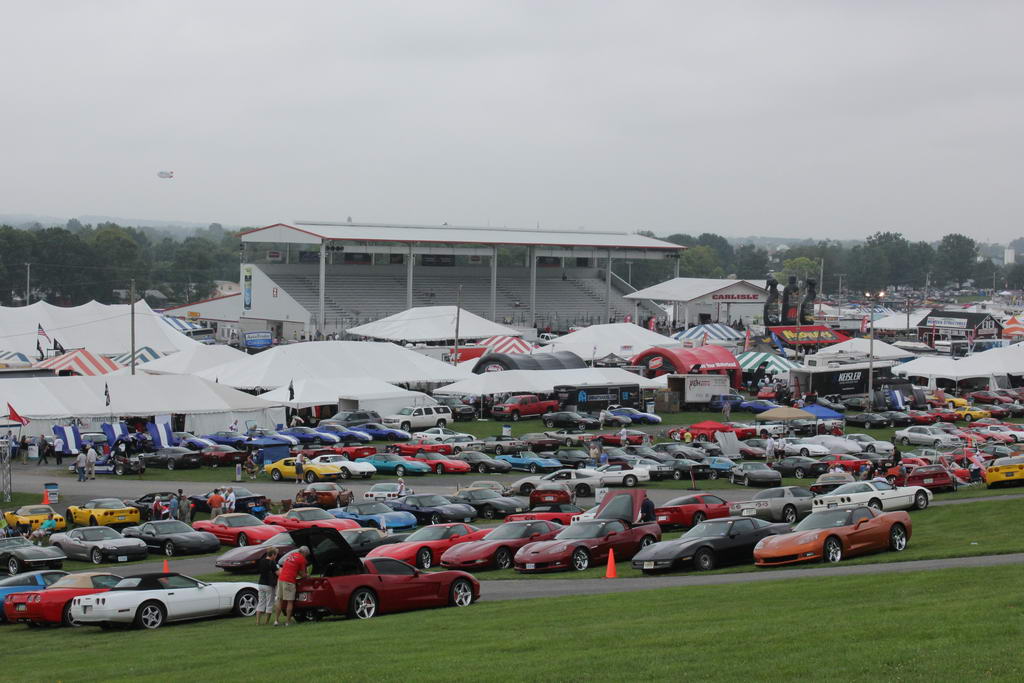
[0,374,285,434]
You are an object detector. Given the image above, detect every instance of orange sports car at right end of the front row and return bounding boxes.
[754,506,910,567]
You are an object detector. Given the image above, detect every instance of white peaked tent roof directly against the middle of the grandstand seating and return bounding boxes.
[345,306,521,342]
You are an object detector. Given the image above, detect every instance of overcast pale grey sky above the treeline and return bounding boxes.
[0,0,1024,241]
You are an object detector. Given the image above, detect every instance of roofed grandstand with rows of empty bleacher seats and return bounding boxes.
[207,222,684,339]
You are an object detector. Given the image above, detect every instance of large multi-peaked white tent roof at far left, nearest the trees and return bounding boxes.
[0,301,199,358]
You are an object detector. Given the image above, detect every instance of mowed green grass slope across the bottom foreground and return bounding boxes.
[0,566,1024,683]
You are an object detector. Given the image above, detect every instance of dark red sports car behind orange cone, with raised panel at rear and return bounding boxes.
[515,488,662,573]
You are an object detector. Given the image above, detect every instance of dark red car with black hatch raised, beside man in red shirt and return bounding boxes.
[290,528,480,618]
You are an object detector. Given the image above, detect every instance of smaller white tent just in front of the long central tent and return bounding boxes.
[260,377,437,415]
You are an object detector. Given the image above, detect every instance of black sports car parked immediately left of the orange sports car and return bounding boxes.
[633,517,793,573]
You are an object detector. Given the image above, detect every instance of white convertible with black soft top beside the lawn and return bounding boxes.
[71,573,258,629]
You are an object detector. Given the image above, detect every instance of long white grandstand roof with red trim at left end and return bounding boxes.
[242,221,685,252]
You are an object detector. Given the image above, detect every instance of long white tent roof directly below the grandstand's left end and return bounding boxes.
[197,341,470,389]
